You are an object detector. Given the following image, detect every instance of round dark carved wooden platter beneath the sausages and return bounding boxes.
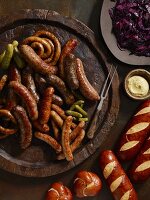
[0,9,120,177]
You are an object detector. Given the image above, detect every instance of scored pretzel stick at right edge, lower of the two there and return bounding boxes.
[129,137,150,182]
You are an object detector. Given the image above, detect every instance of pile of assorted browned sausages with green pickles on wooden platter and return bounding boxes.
[0,30,99,161]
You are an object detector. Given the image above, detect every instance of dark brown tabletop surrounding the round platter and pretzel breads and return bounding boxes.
[0,0,150,200]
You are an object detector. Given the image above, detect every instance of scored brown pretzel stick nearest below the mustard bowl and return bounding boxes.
[117,100,150,160]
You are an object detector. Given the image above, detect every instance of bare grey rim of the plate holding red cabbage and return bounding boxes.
[100,0,150,66]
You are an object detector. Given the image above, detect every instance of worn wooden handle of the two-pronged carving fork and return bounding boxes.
[87,110,99,139]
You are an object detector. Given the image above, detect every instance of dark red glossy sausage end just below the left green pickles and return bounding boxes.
[8,64,21,83]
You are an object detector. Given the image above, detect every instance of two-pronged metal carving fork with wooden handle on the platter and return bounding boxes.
[87,65,117,139]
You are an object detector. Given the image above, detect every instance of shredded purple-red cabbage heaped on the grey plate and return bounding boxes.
[109,0,150,57]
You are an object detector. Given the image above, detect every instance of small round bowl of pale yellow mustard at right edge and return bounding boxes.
[124,69,150,100]
